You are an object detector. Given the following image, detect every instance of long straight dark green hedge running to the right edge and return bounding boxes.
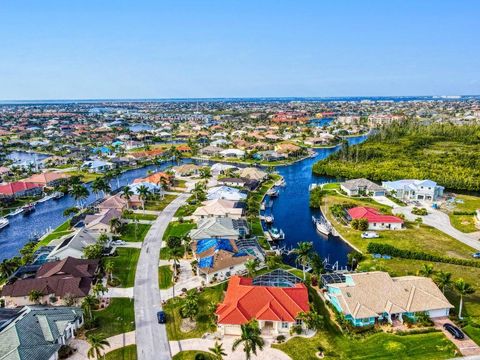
[367,243,480,268]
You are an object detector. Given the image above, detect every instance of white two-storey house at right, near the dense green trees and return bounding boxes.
[382,179,445,201]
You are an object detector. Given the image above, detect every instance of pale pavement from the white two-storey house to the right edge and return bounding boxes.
[393,206,480,251]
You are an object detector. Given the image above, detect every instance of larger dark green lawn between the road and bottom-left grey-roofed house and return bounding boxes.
[87,298,135,337]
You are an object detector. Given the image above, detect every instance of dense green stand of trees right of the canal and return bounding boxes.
[313,121,480,191]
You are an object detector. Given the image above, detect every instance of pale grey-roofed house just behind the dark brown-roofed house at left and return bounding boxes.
[47,228,98,260]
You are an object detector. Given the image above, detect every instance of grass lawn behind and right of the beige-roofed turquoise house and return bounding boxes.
[359,255,480,318]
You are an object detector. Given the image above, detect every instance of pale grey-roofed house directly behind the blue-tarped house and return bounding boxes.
[189,217,249,240]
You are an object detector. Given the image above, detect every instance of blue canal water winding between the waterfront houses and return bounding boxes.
[0,136,366,266]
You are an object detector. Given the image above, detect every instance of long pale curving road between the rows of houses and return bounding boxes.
[133,194,190,360]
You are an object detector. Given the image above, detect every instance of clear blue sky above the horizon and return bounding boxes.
[0,0,480,100]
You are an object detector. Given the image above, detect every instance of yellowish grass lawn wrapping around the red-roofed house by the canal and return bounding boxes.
[322,194,474,259]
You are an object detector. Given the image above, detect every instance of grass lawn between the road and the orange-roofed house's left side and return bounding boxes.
[163,283,227,340]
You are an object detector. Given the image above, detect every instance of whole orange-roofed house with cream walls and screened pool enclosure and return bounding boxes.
[215,270,310,336]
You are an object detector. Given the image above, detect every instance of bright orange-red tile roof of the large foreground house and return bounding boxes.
[216,276,309,325]
